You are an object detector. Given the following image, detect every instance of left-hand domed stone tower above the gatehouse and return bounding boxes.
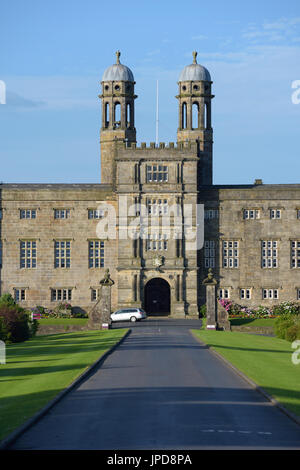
[99,51,137,186]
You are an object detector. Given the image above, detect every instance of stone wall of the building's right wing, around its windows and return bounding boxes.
[199,185,300,307]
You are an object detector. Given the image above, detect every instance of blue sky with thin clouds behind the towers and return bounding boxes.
[0,0,300,184]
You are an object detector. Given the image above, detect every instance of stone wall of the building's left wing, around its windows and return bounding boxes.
[1,185,118,310]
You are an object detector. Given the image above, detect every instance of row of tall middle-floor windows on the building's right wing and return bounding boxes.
[204,240,300,268]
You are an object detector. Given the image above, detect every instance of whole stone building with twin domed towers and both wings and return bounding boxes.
[0,52,300,317]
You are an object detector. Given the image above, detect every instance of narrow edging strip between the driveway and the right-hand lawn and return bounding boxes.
[189,330,300,425]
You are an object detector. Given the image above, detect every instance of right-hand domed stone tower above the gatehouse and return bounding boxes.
[176,52,214,186]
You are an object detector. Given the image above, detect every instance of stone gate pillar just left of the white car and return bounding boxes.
[88,269,114,330]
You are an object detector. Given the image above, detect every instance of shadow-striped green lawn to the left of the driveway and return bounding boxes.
[0,329,127,440]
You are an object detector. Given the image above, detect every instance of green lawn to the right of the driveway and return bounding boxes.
[193,330,300,416]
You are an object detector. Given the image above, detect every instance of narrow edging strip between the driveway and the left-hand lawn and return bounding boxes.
[0,329,131,450]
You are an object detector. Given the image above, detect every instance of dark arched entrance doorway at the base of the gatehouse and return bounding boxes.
[145,277,171,315]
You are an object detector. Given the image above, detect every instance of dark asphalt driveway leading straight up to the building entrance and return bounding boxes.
[8,318,300,450]
